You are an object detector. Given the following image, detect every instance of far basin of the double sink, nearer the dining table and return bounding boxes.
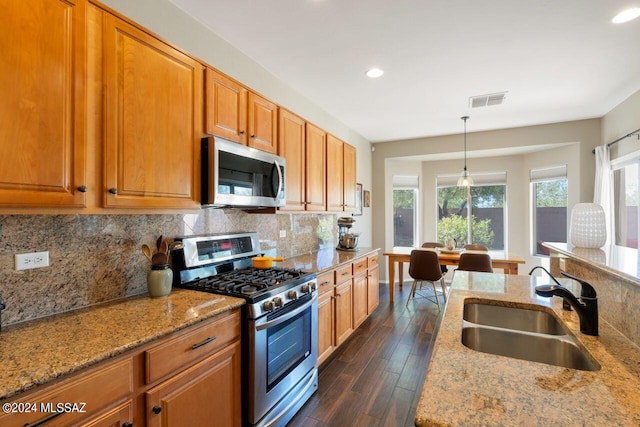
[463,302,568,335]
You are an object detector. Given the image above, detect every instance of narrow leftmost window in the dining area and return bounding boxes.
[393,176,418,247]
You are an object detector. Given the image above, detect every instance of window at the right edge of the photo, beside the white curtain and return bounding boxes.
[613,158,640,249]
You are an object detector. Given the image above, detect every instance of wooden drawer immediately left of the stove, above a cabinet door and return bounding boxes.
[145,310,240,384]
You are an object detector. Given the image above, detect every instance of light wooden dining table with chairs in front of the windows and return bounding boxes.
[382,247,525,303]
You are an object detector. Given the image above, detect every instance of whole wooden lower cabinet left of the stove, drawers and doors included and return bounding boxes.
[0,309,242,427]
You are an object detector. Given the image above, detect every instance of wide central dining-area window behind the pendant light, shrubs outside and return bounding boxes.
[437,172,507,250]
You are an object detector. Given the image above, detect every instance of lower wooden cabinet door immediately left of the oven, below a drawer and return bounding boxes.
[145,342,242,427]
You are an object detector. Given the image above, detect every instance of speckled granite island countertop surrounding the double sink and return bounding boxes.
[415,271,640,426]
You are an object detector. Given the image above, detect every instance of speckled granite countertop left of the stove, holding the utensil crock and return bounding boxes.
[0,289,245,399]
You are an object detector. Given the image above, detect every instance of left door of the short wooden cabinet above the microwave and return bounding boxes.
[205,68,247,145]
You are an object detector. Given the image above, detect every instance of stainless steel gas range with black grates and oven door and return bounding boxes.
[171,233,318,426]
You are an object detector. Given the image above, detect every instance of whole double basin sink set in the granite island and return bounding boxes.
[462,299,600,371]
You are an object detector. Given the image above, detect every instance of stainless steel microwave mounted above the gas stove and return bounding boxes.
[201,136,286,207]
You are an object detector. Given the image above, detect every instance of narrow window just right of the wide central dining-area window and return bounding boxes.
[530,165,568,255]
